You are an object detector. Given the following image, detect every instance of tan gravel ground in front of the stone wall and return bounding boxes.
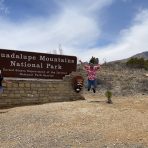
[0,92,148,148]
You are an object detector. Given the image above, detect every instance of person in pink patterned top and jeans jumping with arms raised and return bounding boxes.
[80,60,101,93]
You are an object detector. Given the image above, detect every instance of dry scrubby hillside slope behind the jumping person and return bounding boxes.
[78,62,148,96]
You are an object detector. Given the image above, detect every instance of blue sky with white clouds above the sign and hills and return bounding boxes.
[0,0,148,62]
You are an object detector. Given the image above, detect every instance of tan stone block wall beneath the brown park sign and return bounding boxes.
[0,72,84,107]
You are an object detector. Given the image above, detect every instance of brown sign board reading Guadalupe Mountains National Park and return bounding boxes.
[0,49,77,79]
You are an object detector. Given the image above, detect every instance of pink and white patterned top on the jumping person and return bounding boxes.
[84,64,101,80]
